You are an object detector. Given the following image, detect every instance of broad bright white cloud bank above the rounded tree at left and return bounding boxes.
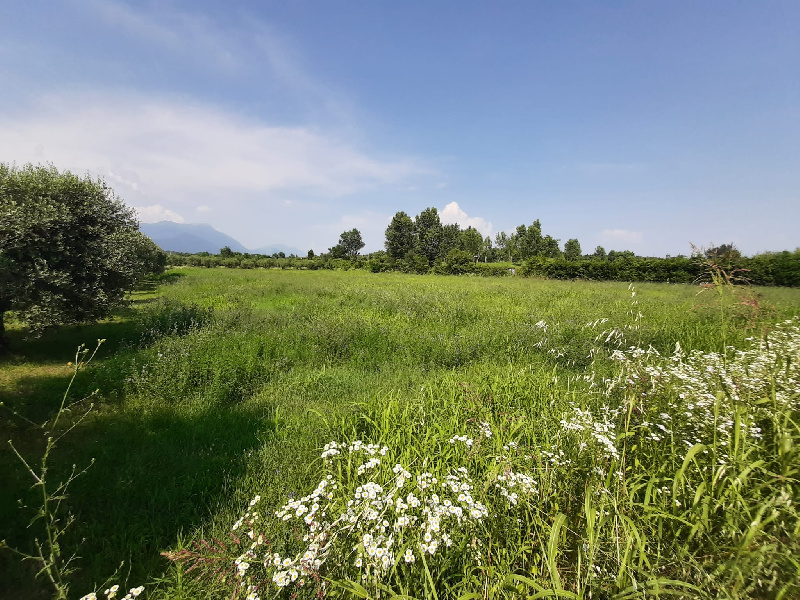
[0,94,426,209]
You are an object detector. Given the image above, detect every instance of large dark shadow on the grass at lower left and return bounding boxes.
[0,400,275,598]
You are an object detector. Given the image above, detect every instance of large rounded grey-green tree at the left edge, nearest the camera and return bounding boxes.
[0,163,166,346]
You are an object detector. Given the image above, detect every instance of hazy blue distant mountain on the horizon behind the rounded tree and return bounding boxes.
[139,221,300,256]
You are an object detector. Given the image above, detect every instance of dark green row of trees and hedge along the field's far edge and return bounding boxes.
[168,208,800,286]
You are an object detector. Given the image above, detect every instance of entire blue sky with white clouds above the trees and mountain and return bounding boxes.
[0,0,800,256]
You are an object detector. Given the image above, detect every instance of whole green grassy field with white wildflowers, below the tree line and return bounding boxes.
[0,269,800,599]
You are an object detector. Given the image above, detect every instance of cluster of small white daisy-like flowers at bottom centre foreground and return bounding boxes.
[227,422,537,594]
